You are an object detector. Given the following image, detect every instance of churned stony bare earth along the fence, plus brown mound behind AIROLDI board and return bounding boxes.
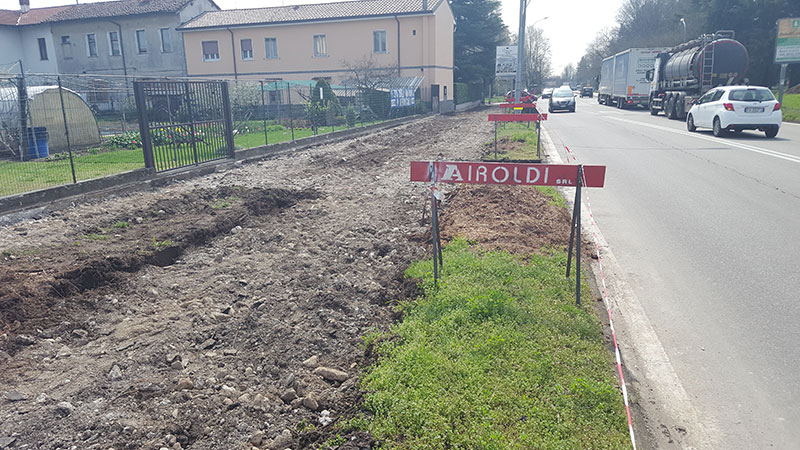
[0,110,569,450]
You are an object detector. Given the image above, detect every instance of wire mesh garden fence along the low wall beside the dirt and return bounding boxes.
[0,74,424,197]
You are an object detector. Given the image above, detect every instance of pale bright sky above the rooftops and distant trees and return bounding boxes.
[0,0,623,73]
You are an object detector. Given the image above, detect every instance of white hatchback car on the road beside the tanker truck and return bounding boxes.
[686,86,783,138]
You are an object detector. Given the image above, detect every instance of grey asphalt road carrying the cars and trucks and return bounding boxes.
[543,99,800,449]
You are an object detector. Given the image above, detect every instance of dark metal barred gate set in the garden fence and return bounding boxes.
[133,81,234,172]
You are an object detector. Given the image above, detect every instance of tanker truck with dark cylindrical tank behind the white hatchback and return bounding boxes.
[646,30,749,120]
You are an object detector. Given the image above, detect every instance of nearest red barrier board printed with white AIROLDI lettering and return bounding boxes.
[411,161,606,187]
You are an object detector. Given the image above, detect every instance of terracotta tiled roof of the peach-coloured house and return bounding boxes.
[179,0,443,30]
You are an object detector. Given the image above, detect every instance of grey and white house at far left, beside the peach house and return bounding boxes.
[0,0,219,77]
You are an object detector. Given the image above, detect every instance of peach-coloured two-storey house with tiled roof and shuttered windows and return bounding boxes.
[179,0,455,103]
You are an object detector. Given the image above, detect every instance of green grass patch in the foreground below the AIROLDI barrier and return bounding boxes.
[360,240,630,449]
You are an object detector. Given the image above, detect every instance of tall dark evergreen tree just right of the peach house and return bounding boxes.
[450,0,508,83]
